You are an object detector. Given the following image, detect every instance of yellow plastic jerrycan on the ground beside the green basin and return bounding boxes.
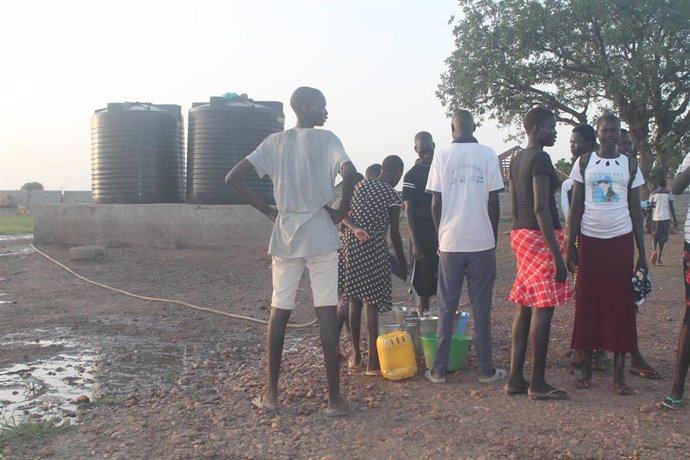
[376,331,417,380]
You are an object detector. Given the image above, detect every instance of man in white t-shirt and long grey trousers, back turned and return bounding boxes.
[425,110,506,383]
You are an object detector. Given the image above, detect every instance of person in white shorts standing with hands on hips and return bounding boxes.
[225,87,357,417]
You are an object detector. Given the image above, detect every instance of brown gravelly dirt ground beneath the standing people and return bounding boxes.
[0,227,690,459]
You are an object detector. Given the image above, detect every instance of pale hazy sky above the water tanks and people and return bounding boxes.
[0,0,569,190]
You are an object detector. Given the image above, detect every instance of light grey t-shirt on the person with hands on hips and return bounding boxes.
[247,128,350,258]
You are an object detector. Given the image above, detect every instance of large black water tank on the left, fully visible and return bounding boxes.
[91,102,185,204]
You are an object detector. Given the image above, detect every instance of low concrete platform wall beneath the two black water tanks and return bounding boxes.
[34,204,273,248]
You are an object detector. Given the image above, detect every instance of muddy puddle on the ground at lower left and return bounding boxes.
[0,328,244,424]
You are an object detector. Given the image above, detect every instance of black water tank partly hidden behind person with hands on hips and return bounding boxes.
[187,97,285,204]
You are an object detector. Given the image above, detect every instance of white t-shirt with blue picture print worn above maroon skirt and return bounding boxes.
[570,153,644,239]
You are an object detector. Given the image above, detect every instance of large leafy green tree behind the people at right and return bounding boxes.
[437,0,690,183]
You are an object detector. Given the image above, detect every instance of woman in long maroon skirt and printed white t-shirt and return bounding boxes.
[567,114,647,395]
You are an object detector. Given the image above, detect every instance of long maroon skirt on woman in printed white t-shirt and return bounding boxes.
[572,233,637,353]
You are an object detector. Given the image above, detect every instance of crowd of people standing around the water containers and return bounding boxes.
[226,87,690,416]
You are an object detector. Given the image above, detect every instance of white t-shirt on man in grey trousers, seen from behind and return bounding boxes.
[426,143,504,252]
